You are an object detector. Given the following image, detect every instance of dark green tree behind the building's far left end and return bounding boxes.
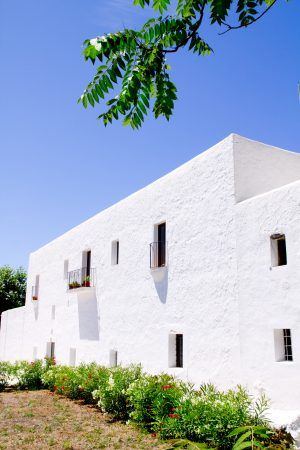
[0,266,26,321]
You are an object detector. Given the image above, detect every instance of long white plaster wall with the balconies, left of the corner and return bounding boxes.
[1,136,239,387]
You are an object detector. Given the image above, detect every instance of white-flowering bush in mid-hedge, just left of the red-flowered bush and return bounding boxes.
[93,365,142,420]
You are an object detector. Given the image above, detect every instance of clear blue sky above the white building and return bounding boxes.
[0,0,300,267]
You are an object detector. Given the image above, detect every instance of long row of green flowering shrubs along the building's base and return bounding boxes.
[0,360,293,450]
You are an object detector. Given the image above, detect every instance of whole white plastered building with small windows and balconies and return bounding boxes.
[0,135,300,410]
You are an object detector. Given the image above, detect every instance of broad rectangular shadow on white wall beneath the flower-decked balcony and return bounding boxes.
[77,292,99,341]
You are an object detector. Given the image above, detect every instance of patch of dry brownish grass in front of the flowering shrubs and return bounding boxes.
[0,391,168,450]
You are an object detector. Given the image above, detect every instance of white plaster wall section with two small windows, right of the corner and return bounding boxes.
[236,181,300,410]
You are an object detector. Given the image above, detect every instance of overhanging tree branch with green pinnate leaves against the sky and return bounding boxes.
[78,0,277,129]
